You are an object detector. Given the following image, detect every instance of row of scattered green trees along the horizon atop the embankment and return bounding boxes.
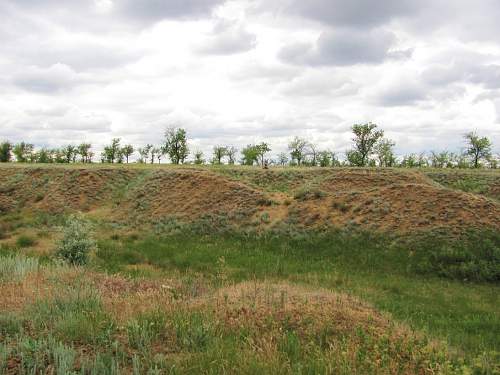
[0,123,499,169]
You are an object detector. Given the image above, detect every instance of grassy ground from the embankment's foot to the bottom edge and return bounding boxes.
[0,216,500,374]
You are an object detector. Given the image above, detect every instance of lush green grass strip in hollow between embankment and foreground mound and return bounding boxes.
[97,232,500,357]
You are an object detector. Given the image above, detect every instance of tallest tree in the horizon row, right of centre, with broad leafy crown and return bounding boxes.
[348,122,384,167]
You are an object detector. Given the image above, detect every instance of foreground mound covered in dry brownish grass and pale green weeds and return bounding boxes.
[0,258,455,374]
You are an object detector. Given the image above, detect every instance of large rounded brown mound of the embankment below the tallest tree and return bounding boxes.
[286,170,500,233]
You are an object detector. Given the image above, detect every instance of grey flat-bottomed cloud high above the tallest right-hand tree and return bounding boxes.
[279,29,396,66]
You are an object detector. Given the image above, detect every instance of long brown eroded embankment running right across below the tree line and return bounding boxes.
[0,167,500,232]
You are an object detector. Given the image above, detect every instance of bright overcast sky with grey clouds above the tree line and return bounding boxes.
[0,0,500,159]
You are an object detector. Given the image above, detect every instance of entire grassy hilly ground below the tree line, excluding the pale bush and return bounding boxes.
[0,165,500,374]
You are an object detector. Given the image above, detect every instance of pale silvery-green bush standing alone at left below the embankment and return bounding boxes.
[57,216,97,265]
